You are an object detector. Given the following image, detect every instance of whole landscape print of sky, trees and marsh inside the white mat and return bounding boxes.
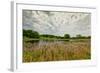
[22,9,91,63]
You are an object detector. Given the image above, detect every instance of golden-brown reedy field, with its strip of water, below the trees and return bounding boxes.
[23,39,91,62]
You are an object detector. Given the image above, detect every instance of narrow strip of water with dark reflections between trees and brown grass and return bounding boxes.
[23,39,89,50]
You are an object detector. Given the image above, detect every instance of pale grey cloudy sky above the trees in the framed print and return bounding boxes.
[23,10,91,36]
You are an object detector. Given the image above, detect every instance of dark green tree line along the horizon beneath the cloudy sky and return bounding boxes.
[23,29,91,39]
